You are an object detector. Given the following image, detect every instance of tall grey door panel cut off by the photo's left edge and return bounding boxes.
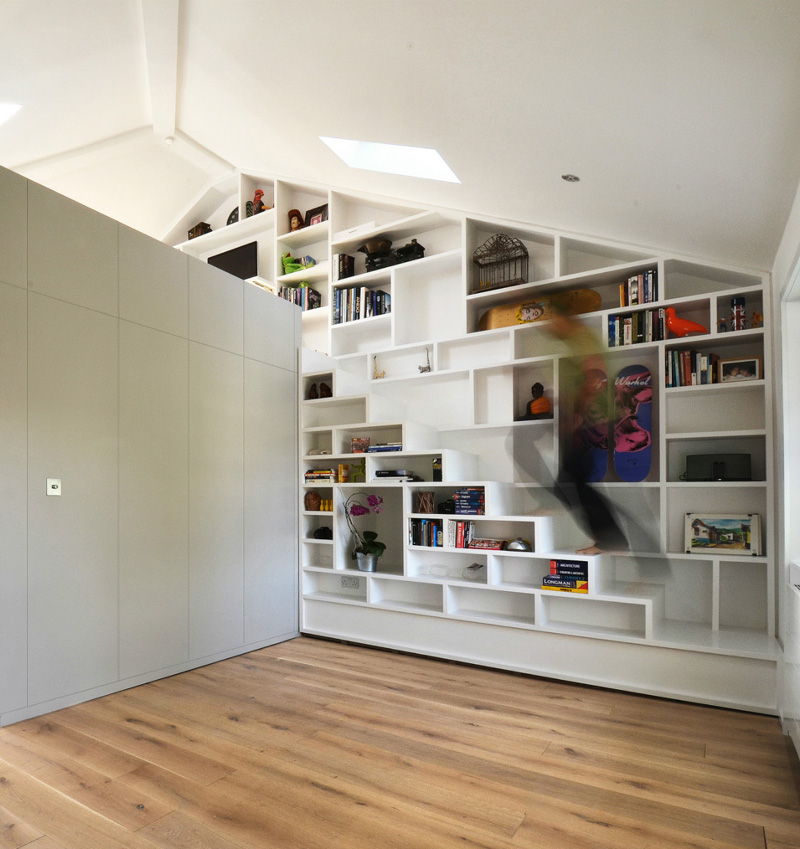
[0,283,28,712]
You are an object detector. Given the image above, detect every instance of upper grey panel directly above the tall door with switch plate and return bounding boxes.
[28,183,119,315]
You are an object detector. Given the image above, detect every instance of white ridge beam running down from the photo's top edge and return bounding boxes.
[140,0,180,139]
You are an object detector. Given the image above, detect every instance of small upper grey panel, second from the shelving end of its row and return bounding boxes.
[189,260,242,355]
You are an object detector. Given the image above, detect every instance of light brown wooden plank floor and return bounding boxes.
[0,638,800,849]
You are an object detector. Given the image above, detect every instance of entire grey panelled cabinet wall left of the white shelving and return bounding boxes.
[0,164,300,724]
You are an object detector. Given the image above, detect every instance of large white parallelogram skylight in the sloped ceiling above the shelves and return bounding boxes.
[320,136,461,183]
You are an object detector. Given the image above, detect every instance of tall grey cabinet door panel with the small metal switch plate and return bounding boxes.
[28,293,118,703]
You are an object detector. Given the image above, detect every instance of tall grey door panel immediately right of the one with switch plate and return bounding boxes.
[119,322,189,678]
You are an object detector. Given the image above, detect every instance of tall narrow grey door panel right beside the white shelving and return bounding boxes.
[245,360,298,643]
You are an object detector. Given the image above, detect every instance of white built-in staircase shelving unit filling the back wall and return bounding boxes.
[167,169,780,712]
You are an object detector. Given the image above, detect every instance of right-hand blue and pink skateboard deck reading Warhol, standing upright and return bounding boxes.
[614,365,653,482]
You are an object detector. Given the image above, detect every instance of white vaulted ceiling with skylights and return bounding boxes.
[0,0,800,269]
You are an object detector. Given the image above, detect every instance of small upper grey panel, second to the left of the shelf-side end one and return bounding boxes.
[119,225,189,337]
